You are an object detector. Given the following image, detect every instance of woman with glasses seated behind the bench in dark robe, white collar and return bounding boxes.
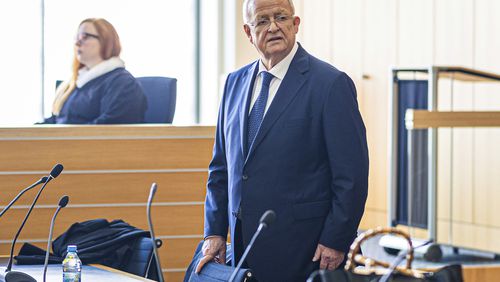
[44,18,146,124]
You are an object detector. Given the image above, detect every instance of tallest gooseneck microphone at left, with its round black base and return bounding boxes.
[0,164,64,282]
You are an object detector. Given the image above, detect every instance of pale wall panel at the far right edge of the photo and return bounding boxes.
[472,0,500,236]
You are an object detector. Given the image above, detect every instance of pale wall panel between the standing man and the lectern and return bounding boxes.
[358,0,396,213]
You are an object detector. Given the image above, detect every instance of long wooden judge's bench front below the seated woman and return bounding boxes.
[0,124,215,281]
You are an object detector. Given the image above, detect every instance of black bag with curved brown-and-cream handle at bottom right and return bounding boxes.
[307,227,463,282]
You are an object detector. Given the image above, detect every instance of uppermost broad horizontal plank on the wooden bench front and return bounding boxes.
[0,138,213,172]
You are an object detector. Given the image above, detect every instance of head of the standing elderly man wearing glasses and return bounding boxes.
[244,0,300,67]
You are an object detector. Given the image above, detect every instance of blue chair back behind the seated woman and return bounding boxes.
[137,76,177,123]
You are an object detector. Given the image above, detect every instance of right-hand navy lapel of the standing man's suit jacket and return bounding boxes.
[245,45,309,163]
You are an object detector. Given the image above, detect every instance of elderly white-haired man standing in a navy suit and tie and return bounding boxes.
[197,0,368,282]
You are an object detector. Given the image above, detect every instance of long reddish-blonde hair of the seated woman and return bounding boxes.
[52,18,122,116]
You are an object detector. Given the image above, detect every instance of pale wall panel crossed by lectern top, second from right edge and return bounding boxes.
[433,0,474,235]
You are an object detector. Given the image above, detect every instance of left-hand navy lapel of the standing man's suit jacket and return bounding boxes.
[239,61,259,158]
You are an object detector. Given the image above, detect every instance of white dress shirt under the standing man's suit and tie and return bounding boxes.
[248,42,299,116]
